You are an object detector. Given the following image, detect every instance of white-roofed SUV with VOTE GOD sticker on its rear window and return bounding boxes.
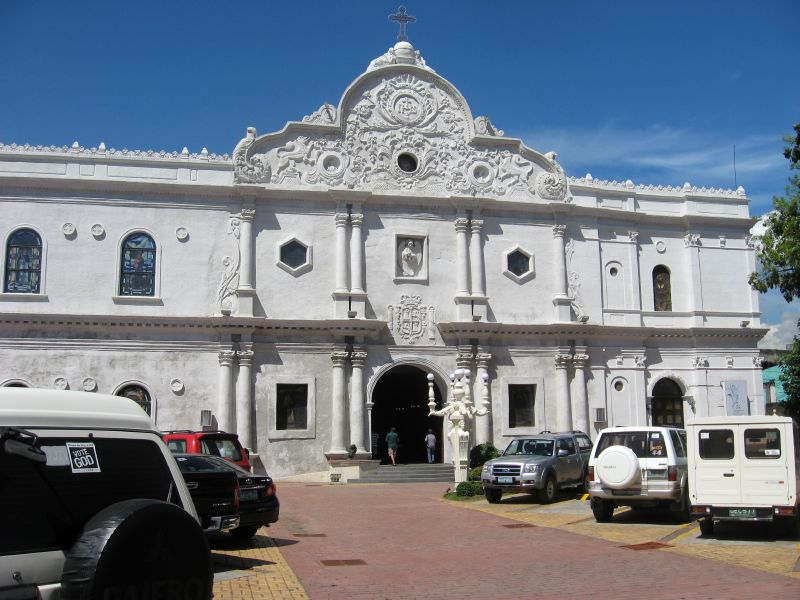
[0,388,213,600]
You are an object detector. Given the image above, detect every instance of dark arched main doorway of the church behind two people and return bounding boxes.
[371,365,444,464]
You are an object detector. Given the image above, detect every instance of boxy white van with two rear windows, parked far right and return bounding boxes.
[686,416,800,536]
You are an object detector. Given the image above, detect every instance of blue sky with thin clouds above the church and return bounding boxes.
[0,0,800,345]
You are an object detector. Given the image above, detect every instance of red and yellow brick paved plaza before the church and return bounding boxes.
[213,483,800,600]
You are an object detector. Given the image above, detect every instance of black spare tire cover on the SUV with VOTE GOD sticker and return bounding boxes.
[61,499,214,600]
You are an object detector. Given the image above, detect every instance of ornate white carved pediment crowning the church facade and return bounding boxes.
[233,43,567,201]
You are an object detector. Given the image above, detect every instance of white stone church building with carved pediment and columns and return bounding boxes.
[0,31,766,477]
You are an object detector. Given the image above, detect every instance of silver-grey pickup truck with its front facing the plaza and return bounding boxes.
[481,431,592,504]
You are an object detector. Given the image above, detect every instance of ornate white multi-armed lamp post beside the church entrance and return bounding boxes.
[428,369,489,483]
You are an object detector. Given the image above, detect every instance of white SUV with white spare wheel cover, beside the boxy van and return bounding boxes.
[587,427,689,521]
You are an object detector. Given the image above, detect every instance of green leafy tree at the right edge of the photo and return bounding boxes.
[750,123,800,420]
